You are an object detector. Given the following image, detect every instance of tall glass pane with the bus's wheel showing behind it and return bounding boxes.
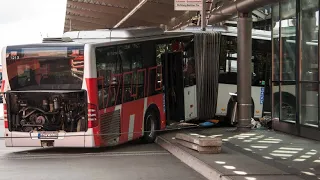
[274,0,298,123]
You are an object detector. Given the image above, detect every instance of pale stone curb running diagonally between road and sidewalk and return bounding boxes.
[156,136,231,180]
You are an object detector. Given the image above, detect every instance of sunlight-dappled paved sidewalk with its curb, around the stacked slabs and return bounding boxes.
[157,128,320,180]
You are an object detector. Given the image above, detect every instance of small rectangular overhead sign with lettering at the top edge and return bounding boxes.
[174,0,202,11]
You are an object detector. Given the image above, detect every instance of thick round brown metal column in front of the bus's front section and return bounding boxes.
[237,12,252,130]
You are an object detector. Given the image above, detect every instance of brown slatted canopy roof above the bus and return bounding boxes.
[64,0,270,31]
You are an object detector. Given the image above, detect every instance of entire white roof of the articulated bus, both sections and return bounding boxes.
[5,26,271,47]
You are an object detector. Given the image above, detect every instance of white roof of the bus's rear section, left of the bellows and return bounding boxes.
[4,27,192,47]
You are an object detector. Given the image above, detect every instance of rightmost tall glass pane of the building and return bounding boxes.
[300,0,319,126]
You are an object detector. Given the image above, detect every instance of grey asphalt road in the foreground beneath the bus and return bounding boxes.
[0,120,204,180]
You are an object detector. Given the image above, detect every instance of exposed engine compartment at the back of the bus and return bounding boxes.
[6,91,88,132]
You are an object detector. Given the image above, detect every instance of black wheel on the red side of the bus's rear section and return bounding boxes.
[142,111,158,143]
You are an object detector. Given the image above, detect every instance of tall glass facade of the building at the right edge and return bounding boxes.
[272,0,320,132]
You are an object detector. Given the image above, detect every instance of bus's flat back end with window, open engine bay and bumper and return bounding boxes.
[2,44,88,147]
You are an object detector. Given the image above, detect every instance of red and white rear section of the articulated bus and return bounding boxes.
[2,27,197,147]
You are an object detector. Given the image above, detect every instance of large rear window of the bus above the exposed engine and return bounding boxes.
[6,46,84,90]
